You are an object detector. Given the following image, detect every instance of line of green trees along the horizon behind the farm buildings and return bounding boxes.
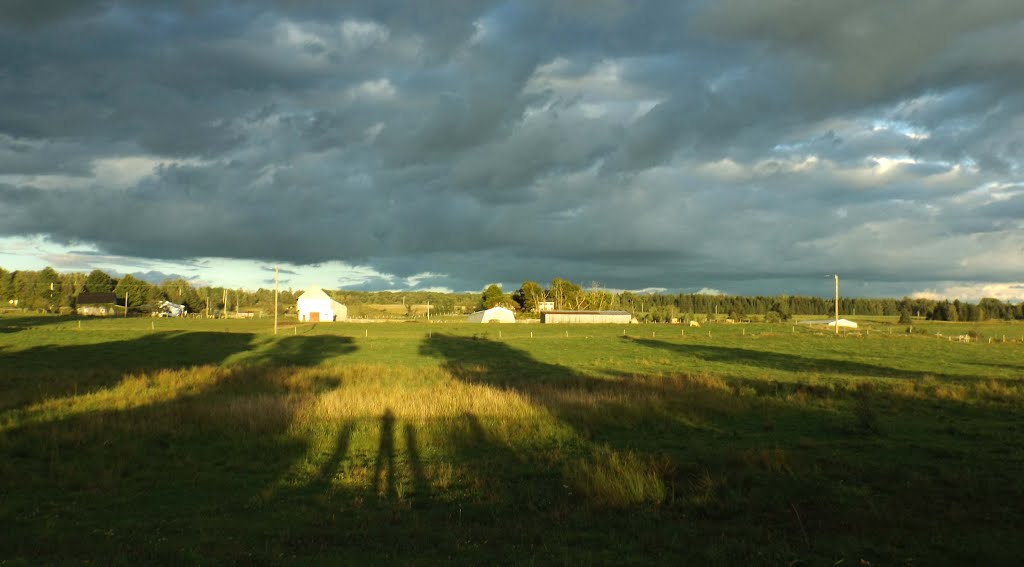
[0,267,1024,322]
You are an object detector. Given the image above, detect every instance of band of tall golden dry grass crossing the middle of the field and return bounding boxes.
[0,358,1024,508]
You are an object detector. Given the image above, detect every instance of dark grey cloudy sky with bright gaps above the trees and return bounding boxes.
[0,0,1024,302]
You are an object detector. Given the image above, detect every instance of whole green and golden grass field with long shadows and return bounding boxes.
[0,315,1024,565]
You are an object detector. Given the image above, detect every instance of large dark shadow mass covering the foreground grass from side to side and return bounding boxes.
[0,336,1024,565]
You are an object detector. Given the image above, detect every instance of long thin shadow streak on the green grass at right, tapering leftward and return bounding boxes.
[620,337,995,382]
